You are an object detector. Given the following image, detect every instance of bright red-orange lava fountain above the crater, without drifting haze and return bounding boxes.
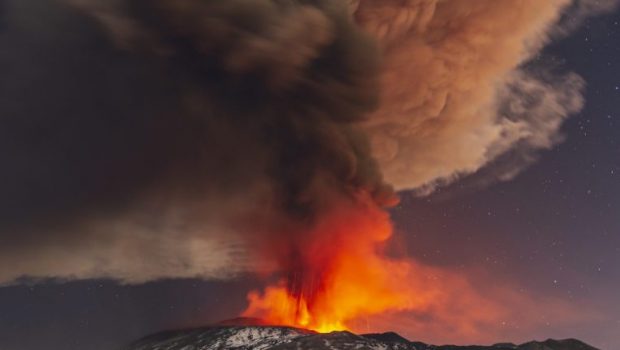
[243,194,414,332]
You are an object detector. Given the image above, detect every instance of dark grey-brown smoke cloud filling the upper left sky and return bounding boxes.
[0,0,393,282]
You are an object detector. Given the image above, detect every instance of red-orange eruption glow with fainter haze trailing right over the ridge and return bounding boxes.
[243,191,590,343]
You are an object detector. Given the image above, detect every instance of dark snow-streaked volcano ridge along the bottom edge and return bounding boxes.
[127,326,598,350]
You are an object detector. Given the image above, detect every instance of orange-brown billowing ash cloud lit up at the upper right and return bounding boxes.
[355,0,592,193]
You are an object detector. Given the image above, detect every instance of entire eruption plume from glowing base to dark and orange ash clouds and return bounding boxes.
[0,0,616,340]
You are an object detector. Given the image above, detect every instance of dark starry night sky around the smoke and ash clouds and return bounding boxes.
[0,2,620,350]
